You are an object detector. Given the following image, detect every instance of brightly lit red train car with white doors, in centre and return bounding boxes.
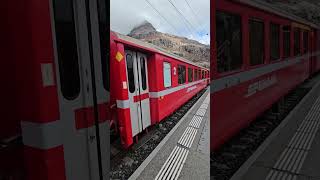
[110,32,209,148]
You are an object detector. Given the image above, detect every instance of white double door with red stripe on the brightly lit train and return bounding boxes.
[125,50,151,137]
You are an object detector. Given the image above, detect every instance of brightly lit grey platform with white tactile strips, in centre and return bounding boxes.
[129,88,210,180]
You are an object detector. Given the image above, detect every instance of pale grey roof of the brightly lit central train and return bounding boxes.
[112,31,209,70]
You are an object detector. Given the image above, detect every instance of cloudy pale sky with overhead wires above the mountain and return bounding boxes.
[110,0,210,44]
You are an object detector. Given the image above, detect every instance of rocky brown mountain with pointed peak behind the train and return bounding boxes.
[128,22,210,67]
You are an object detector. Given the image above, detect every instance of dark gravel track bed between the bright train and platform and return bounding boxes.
[110,88,207,179]
